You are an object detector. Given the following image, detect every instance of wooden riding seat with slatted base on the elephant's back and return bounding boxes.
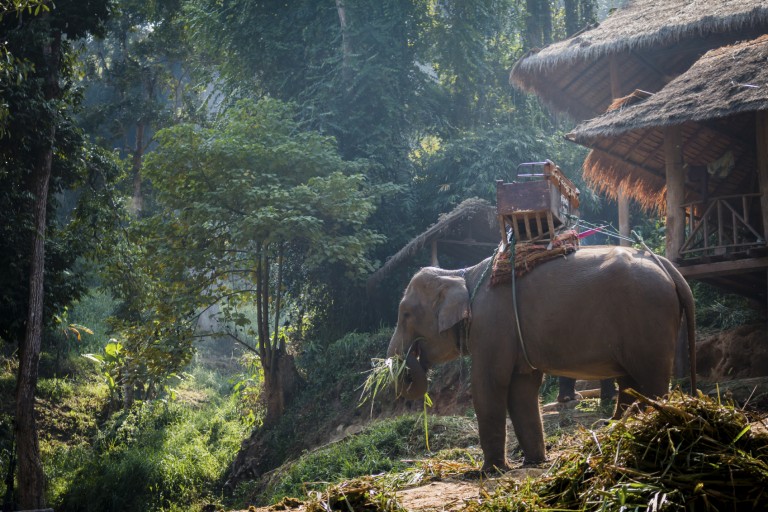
[496,160,579,251]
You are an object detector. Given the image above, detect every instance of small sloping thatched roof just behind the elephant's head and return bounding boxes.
[367,198,501,291]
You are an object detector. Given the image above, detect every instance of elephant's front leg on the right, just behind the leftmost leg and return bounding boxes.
[508,370,547,464]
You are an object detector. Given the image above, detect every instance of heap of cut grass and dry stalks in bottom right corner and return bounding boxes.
[468,392,768,511]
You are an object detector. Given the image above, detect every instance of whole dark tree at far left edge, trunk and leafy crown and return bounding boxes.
[0,0,108,509]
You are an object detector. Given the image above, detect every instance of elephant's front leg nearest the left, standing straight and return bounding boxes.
[472,370,509,472]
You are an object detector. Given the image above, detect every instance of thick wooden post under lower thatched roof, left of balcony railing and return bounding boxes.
[664,126,685,262]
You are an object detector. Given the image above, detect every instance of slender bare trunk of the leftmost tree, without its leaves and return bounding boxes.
[16,34,61,509]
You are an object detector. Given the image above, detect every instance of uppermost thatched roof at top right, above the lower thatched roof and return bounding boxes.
[510,0,768,119]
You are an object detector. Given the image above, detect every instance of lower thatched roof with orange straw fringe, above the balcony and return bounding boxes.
[567,35,768,207]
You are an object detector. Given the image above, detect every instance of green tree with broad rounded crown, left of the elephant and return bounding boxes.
[138,99,388,423]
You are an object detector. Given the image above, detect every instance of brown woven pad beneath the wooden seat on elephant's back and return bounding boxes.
[491,230,579,286]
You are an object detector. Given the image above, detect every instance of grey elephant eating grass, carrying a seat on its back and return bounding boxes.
[387,246,696,471]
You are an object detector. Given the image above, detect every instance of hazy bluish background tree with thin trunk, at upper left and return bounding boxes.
[82,0,192,216]
